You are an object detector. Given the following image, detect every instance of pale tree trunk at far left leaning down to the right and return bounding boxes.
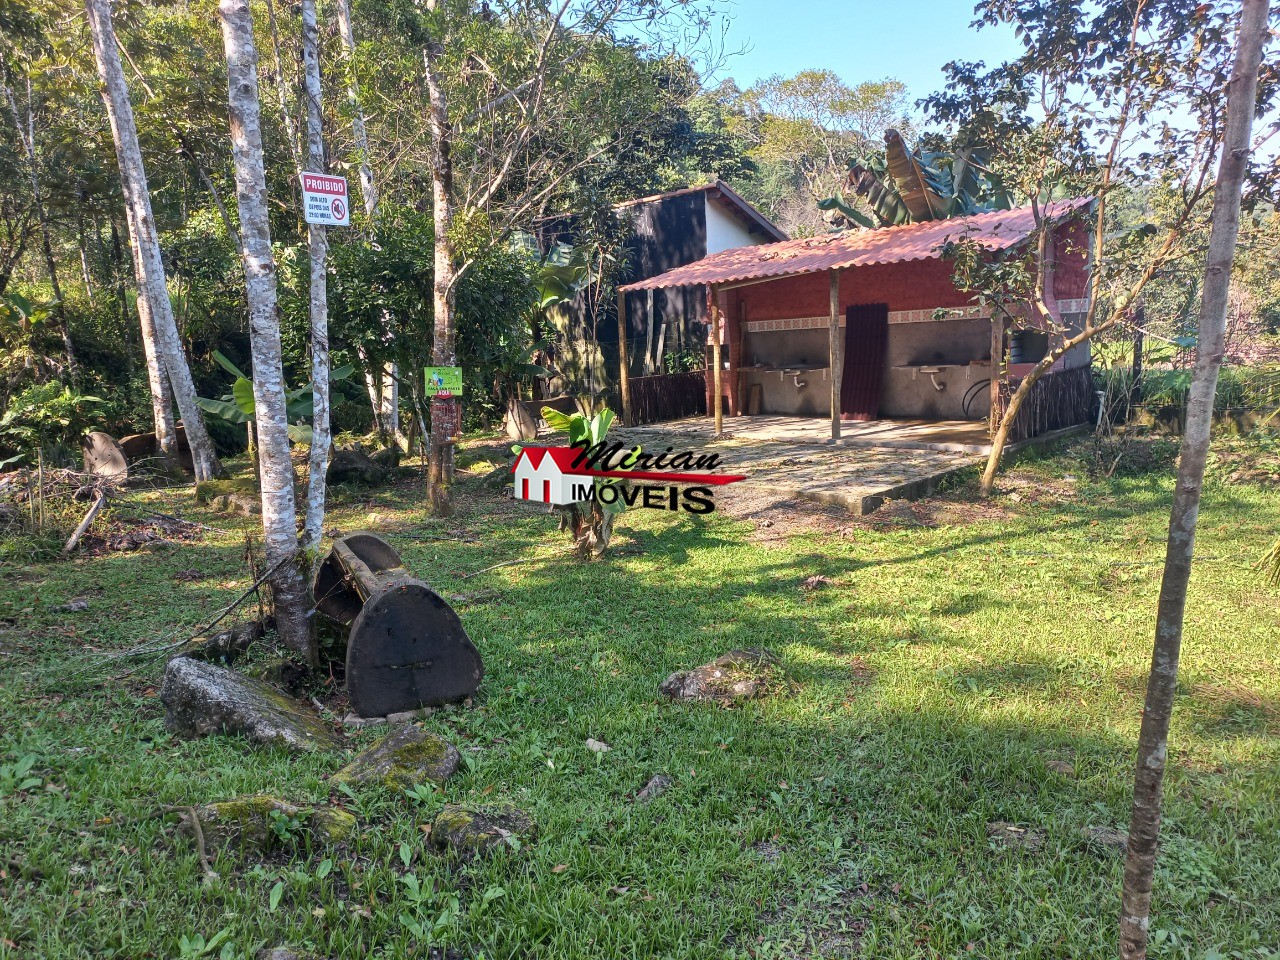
[84,0,223,481]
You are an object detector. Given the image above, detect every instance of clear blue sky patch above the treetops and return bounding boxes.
[722,0,1018,113]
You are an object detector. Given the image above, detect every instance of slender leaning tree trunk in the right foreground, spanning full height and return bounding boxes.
[1120,0,1268,960]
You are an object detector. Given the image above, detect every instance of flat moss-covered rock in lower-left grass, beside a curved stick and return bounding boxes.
[178,794,356,855]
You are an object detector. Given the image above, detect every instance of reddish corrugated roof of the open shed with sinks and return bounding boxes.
[620,197,1092,291]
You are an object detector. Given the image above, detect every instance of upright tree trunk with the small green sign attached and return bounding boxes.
[422,44,457,516]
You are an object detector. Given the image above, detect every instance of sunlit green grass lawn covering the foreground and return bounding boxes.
[0,437,1280,960]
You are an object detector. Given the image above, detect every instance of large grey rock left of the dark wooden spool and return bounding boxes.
[160,657,338,751]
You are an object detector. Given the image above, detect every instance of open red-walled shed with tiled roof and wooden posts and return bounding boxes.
[620,200,1093,450]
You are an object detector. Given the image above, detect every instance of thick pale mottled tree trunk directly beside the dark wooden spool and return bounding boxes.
[218,0,317,666]
